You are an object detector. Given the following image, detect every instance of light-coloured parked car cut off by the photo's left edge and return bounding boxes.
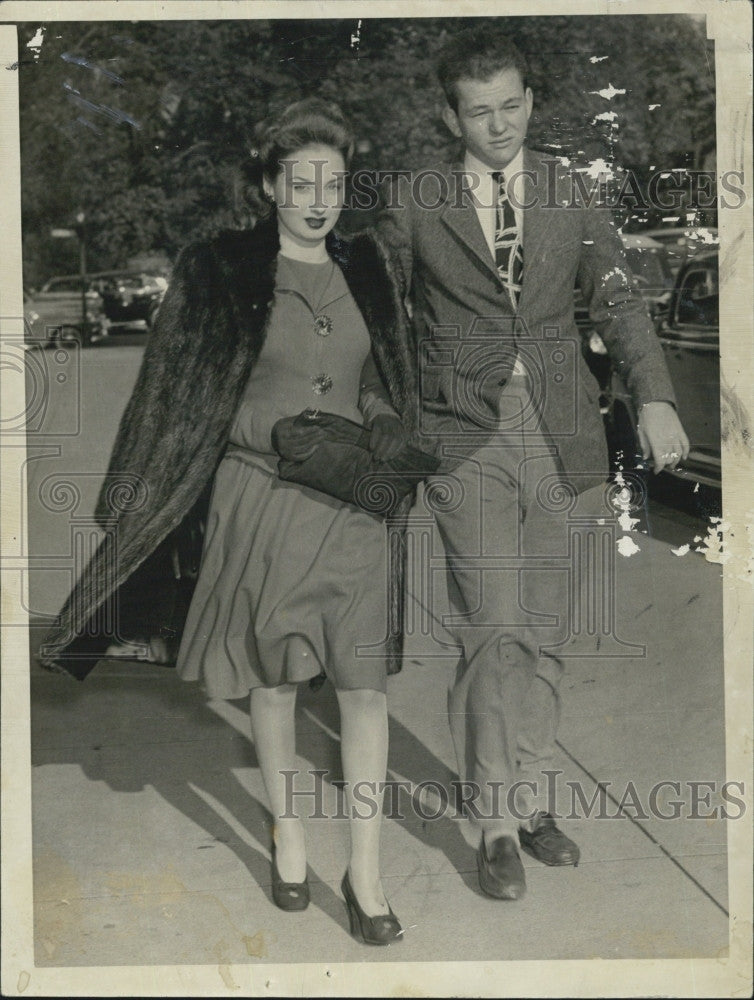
[24,274,105,347]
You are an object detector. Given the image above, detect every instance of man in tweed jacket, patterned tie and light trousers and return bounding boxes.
[374,24,688,899]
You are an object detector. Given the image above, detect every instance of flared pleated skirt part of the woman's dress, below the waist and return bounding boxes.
[177,449,388,699]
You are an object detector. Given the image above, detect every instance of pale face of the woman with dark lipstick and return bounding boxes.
[264,145,346,246]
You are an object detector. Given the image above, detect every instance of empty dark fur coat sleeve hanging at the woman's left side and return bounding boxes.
[95,243,218,525]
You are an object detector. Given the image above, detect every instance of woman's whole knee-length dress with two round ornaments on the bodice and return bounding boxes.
[177,254,388,698]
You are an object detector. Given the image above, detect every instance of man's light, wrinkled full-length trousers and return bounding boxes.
[428,375,569,835]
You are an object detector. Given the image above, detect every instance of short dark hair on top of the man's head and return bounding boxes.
[437,21,529,111]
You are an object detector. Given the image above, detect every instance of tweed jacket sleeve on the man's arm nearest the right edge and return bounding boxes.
[577,207,675,407]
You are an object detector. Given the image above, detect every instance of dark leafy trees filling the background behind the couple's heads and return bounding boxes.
[18,15,715,286]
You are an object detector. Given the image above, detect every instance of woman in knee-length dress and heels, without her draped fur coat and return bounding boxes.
[178,100,403,943]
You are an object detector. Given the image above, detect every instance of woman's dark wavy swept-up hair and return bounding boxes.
[243,97,354,218]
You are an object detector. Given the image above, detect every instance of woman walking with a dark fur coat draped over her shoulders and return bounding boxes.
[42,99,420,944]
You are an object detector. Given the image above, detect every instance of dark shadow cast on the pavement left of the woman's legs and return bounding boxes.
[31,661,347,931]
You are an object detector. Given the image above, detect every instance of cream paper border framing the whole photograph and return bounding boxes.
[0,0,754,997]
